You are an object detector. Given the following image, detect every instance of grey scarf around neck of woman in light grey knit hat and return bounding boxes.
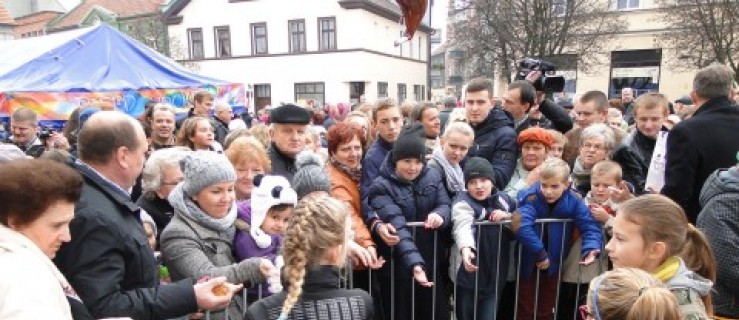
[168,182,237,238]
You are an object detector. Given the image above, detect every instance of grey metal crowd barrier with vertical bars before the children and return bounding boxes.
[205,219,607,320]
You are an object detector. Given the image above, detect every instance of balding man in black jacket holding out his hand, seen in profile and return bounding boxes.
[54,111,240,319]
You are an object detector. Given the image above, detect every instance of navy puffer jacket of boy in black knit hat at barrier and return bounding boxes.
[367,151,451,278]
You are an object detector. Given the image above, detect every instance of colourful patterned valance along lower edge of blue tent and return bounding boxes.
[0,84,249,120]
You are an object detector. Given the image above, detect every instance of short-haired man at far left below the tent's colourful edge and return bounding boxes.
[10,107,69,158]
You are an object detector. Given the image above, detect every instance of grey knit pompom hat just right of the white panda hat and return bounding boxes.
[293,151,331,199]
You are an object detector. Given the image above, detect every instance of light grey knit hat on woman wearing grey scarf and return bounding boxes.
[180,151,236,196]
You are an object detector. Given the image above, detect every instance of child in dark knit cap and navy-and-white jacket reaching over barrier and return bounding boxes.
[450,157,516,320]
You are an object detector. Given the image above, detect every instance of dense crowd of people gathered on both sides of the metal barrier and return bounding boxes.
[0,65,739,320]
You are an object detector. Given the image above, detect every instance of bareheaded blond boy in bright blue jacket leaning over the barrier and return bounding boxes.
[513,158,603,319]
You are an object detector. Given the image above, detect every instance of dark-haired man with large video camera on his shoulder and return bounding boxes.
[503,71,572,134]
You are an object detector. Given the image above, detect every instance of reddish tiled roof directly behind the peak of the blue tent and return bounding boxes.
[48,0,165,30]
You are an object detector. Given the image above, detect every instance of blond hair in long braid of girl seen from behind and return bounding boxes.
[278,196,347,320]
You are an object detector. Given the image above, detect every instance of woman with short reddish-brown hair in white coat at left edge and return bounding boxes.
[0,159,84,320]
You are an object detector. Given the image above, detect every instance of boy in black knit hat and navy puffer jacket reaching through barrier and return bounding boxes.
[366,125,451,320]
